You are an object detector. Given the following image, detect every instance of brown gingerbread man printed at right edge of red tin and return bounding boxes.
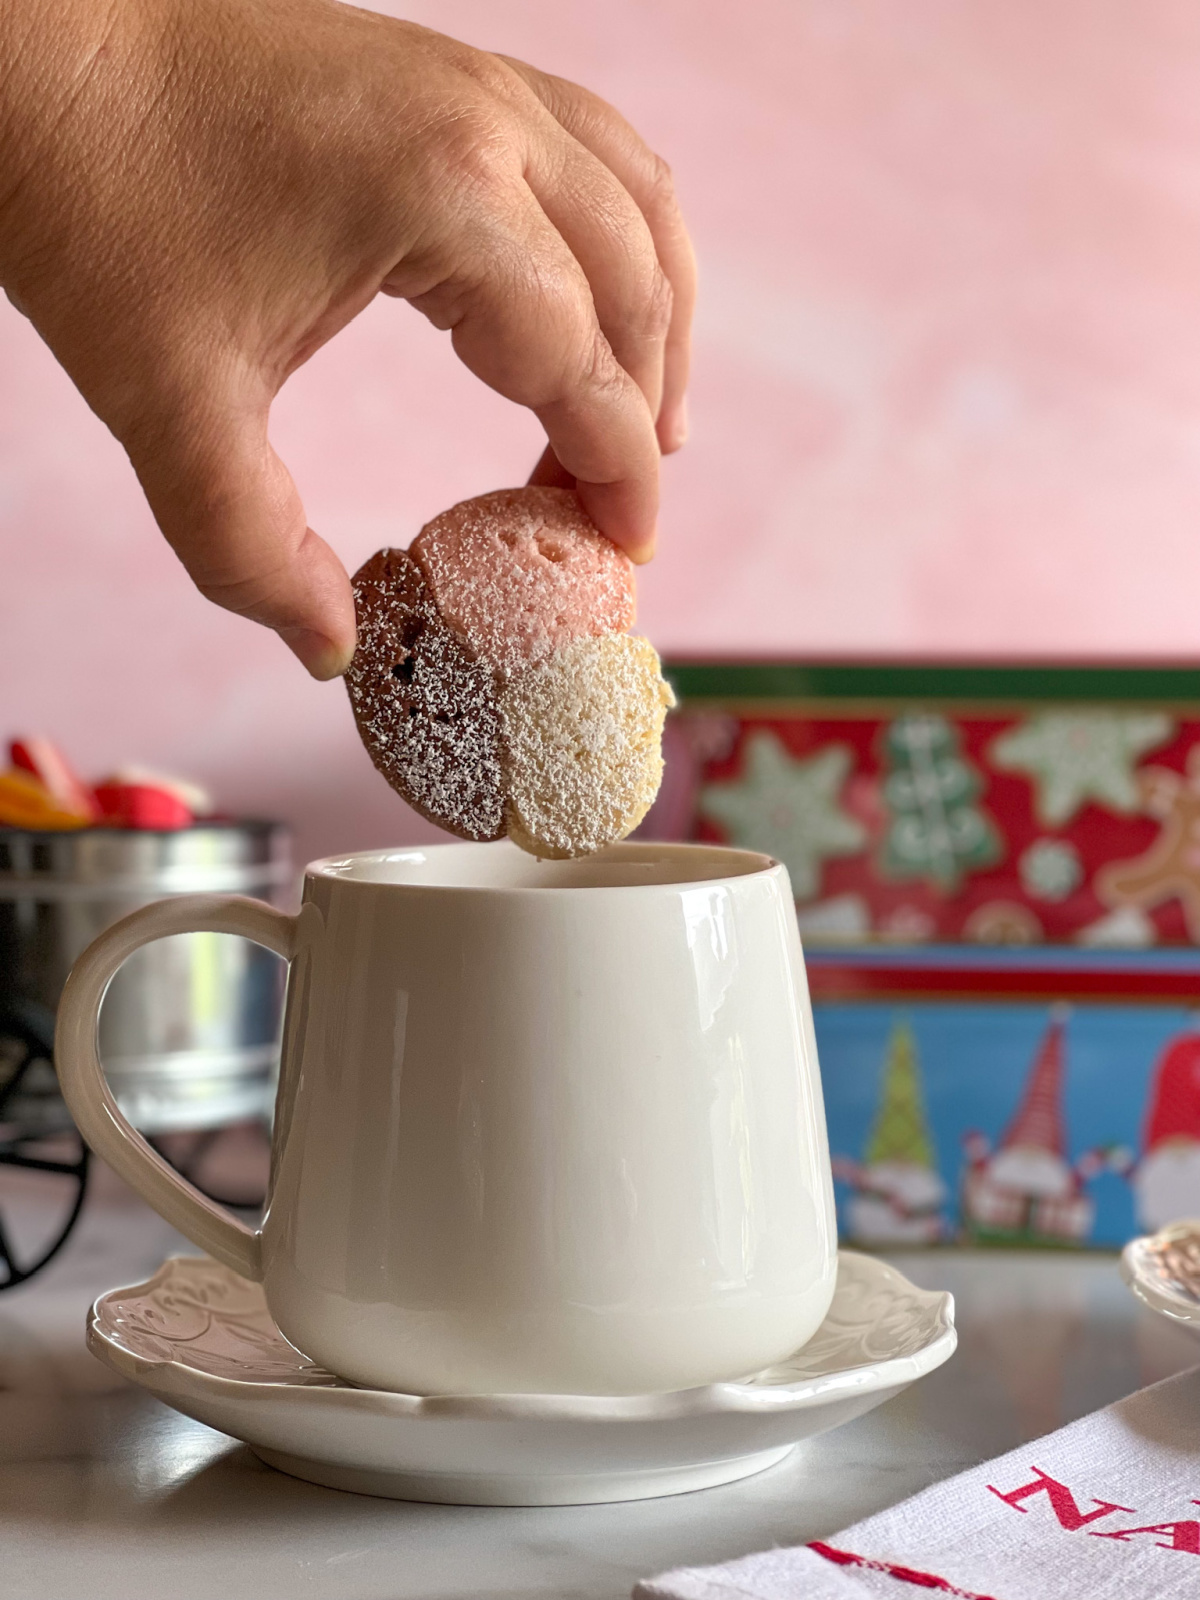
[1096,744,1200,942]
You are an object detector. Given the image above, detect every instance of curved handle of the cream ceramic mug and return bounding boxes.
[54,894,299,1283]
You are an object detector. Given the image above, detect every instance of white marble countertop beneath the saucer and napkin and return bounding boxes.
[0,1182,1200,1600]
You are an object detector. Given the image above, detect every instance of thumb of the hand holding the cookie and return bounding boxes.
[125,384,355,678]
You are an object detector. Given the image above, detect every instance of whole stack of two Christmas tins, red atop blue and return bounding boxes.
[645,662,1200,1248]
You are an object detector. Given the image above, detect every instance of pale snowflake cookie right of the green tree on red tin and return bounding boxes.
[989,707,1174,827]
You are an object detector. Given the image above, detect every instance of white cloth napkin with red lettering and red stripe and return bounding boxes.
[634,1368,1200,1600]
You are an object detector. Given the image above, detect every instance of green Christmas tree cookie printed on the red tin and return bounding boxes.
[880,712,1003,893]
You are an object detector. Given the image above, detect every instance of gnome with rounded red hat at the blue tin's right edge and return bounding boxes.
[1133,1016,1200,1232]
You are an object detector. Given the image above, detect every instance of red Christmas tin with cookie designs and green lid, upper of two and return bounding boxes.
[651,664,1200,947]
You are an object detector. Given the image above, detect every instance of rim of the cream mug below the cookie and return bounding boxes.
[304,838,786,896]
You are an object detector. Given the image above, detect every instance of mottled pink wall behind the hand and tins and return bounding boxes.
[0,0,1200,856]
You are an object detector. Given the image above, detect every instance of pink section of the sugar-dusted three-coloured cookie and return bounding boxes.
[411,488,635,677]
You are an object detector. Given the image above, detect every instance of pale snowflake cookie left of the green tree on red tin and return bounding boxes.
[699,728,867,901]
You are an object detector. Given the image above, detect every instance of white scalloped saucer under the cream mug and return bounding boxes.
[88,1251,957,1506]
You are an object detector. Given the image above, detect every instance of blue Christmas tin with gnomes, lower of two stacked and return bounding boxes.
[808,950,1200,1248]
